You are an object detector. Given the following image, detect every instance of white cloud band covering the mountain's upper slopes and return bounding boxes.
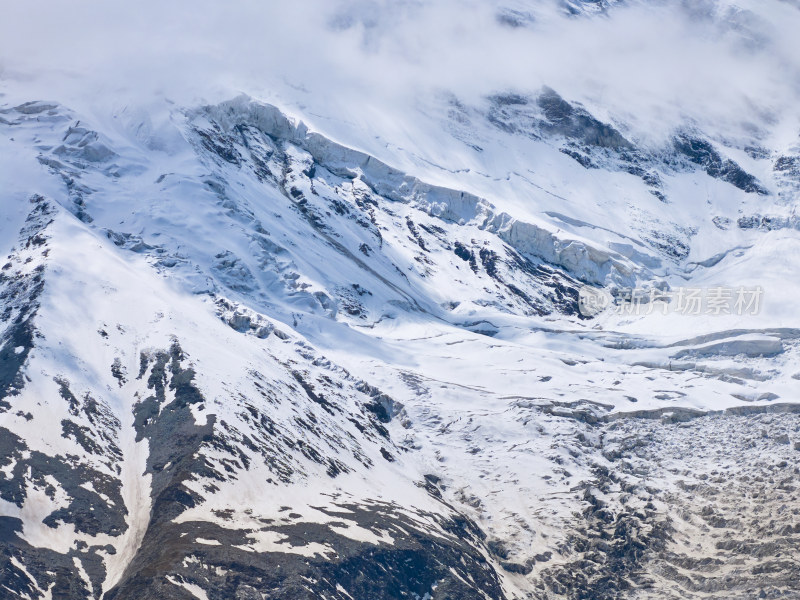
[0,0,800,144]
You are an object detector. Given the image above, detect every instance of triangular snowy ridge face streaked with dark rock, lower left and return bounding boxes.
[2,105,512,598]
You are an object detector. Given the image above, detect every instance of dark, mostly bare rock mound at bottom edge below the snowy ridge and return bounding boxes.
[107,504,505,600]
